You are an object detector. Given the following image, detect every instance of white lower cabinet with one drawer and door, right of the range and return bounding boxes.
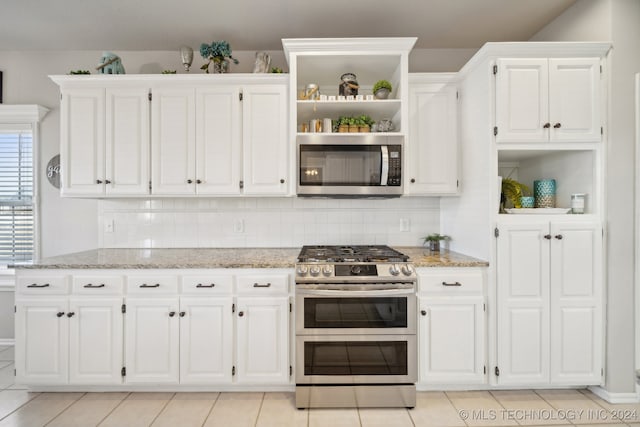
[418,268,487,385]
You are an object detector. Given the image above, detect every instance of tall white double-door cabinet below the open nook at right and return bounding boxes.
[496,219,603,386]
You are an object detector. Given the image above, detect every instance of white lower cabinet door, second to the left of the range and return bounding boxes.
[180,297,233,384]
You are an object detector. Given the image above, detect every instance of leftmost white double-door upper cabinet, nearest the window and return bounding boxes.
[60,82,149,196]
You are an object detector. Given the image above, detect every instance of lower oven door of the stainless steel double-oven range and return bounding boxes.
[296,335,418,384]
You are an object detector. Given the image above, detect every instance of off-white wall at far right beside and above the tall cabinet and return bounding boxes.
[532,0,640,393]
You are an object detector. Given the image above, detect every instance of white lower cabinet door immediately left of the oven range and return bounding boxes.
[236,297,289,384]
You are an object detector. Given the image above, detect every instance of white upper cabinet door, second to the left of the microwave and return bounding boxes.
[196,85,242,194]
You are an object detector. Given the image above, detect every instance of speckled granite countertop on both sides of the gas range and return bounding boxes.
[14,247,488,269]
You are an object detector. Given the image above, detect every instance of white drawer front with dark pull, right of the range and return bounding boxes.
[418,269,483,294]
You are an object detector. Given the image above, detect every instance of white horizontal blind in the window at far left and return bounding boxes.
[0,129,34,264]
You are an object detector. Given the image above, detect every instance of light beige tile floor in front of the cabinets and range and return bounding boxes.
[0,346,640,427]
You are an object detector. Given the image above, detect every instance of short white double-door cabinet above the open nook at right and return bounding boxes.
[494,58,602,142]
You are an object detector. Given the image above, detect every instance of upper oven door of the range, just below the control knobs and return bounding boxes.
[296,288,417,335]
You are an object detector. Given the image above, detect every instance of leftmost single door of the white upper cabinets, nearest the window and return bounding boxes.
[60,89,105,196]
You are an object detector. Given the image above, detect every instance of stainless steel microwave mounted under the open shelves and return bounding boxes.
[296,133,403,197]
